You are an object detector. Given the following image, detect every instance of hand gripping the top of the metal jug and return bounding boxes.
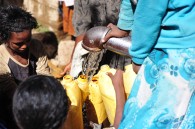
[101,23,129,43]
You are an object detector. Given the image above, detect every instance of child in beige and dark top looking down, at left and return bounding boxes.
[0,6,49,84]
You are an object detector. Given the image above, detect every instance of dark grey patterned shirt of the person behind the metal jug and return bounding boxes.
[73,0,120,36]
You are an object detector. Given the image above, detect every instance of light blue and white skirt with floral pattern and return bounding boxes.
[119,48,195,129]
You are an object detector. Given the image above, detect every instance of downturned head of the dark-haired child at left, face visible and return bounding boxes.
[0,6,38,52]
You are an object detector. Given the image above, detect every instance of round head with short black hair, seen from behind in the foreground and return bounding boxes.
[13,75,68,129]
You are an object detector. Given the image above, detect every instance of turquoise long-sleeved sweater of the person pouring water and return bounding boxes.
[126,0,195,64]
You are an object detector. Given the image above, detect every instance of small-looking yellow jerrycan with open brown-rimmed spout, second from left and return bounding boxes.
[76,75,89,103]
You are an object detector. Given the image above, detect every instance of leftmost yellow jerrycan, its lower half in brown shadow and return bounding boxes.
[61,75,83,129]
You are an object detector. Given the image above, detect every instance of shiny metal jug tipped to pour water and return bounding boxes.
[82,26,131,57]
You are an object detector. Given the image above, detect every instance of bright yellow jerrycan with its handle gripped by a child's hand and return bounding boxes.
[98,65,116,124]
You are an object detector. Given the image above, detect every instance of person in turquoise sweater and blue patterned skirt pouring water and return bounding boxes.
[104,0,195,129]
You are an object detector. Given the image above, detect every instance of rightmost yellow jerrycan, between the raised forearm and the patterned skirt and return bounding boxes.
[123,64,136,98]
